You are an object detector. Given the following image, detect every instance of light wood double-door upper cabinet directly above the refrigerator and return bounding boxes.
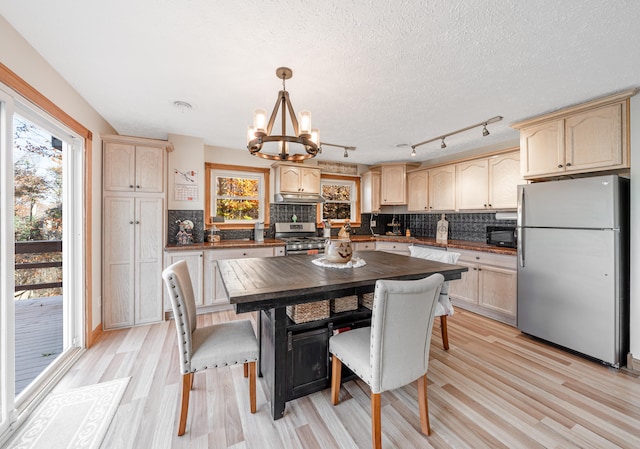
[512,89,637,179]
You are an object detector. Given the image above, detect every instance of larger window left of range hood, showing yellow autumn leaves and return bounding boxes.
[205,163,269,228]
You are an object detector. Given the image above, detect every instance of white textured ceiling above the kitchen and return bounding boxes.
[0,0,640,164]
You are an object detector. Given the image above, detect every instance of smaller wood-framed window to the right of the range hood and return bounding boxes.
[320,175,360,225]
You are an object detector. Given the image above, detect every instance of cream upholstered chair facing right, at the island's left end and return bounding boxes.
[162,260,258,435]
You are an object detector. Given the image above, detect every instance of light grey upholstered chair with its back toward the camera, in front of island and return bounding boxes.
[329,274,444,449]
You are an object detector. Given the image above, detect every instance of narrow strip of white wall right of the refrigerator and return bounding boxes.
[630,95,640,364]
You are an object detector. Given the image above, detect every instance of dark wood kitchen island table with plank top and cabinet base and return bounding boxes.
[218,251,467,419]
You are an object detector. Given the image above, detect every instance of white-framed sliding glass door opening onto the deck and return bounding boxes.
[0,86,85,434]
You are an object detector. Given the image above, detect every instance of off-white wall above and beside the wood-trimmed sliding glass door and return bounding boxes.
[0,15,116,329]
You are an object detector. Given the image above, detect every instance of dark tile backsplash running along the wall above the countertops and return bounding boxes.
[167,204,516,244]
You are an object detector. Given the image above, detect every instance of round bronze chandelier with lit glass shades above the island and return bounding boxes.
[247,67,322,161]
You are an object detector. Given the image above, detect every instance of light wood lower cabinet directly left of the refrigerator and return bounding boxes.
[449,249,518,326]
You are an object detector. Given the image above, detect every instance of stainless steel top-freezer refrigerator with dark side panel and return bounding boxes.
[517,175,629,367]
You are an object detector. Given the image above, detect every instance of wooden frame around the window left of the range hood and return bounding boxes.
[204,162,270,229]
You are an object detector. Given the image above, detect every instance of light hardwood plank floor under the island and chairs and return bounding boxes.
[50,309,640,449]
